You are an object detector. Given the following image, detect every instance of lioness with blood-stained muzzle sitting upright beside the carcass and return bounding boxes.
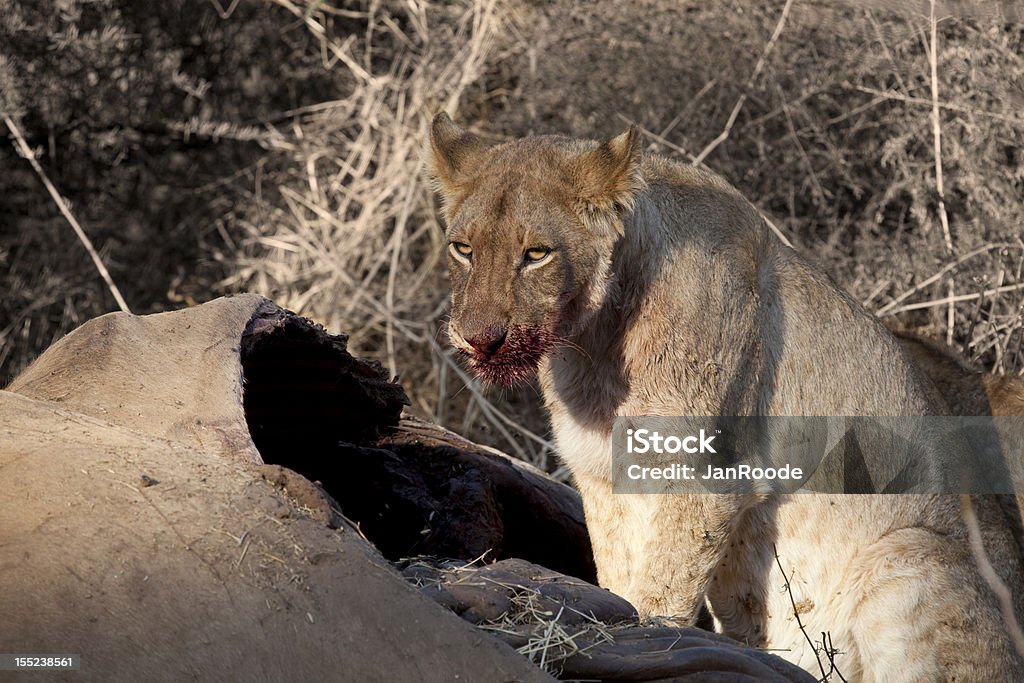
[427,114,1024,680]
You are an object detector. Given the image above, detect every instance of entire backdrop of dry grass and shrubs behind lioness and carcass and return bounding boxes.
[0,0,1024,469]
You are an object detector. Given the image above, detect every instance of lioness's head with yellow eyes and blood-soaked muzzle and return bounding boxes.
[427,114,642,385]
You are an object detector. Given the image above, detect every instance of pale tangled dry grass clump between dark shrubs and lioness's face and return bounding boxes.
[199,0,552,466]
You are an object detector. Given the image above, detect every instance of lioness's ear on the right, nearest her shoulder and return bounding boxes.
[575,126,644,220]
